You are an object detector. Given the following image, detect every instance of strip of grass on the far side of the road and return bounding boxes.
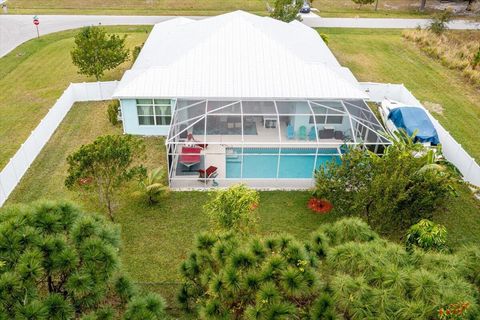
[4,0,442,18]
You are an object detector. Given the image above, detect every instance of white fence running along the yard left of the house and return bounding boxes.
[0,81,117,206]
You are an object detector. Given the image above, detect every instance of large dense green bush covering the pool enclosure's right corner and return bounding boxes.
[314,134,456,231]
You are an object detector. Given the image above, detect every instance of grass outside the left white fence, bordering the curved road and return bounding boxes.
[0,27,151,169]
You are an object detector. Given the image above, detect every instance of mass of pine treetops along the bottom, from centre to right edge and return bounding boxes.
[178,218,480,320]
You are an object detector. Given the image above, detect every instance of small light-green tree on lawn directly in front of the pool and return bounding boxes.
[203,184,259,234]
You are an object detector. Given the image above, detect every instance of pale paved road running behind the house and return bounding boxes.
[0,14,480,57]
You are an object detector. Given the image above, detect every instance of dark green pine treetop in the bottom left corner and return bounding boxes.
[0,202,163,320]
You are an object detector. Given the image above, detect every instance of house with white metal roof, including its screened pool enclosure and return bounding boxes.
[114,11,389,189]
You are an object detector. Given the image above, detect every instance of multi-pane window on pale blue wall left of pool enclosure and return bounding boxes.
[137,99,172,126]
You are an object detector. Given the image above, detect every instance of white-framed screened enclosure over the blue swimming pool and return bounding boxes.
[167,99,390,189]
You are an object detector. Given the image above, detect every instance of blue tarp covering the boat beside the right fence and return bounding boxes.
[388,107,440,145]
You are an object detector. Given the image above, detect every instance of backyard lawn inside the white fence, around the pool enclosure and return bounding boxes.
[7,102,480,314]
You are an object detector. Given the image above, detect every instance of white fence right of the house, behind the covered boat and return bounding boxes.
[360,82,480,187]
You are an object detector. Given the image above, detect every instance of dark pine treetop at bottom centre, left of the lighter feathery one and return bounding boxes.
[179,233,336,319]
